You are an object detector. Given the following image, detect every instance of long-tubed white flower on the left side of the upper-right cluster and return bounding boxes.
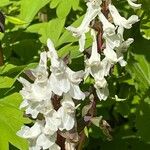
[66,0,102,52]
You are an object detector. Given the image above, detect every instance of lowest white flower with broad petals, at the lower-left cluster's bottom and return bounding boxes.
[17,121,59,150]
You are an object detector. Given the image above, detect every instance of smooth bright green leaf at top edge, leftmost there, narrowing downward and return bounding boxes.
[20,0,50,23]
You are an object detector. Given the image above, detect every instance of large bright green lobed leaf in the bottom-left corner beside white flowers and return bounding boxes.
[0,93,30,150]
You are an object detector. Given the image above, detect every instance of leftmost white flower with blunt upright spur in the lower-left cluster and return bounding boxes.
[18,52,52,102]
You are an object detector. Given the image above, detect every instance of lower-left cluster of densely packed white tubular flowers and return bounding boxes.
[17,39,85,150]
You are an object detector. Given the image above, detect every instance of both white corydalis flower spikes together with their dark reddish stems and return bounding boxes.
[17,0,141,150]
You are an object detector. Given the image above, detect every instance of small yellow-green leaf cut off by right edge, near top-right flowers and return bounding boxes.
[140,12,150,40]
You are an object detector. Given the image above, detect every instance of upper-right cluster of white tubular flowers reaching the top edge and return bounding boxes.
[67,0,141,100]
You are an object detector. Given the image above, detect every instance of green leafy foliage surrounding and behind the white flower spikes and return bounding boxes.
[0,0,150,150]
